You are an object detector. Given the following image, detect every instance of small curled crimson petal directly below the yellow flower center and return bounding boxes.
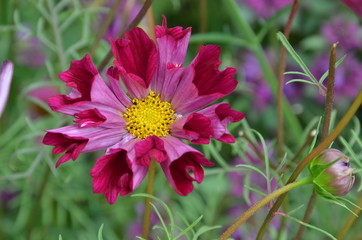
[135,136,167,167]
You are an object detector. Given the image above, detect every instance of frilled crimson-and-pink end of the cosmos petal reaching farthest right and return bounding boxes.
[198,103,245,143]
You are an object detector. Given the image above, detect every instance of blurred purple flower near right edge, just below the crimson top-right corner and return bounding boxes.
[322,18,362,50]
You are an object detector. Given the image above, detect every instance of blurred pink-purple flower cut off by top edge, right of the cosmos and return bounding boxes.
[238,0,293,18]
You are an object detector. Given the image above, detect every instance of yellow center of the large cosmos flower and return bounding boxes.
[122,90,175,139]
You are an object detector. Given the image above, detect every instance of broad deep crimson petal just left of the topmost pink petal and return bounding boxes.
[110,28,158,88]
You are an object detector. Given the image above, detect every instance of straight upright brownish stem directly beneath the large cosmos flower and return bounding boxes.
[142,159,156,239]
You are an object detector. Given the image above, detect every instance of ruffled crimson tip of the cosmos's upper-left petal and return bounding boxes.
[49,55,99,111]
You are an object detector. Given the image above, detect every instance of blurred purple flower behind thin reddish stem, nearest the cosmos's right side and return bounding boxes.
[242,51,304,111]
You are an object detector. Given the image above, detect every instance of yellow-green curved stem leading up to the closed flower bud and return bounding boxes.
[219,177,312,240]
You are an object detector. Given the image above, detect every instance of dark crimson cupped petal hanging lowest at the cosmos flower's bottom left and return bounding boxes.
[90,150,133,204]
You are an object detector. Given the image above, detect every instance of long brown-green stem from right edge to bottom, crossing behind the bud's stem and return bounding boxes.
[256,90,362,240]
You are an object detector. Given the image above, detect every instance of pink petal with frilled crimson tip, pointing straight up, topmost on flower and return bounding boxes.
[151,17,191,98]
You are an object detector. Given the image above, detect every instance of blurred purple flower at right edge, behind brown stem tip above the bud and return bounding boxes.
[311,54,362,104]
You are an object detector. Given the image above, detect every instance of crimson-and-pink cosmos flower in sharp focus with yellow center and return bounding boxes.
[43,18,245,204]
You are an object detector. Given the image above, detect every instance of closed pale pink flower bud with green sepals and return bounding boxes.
[309,149,355,197]
